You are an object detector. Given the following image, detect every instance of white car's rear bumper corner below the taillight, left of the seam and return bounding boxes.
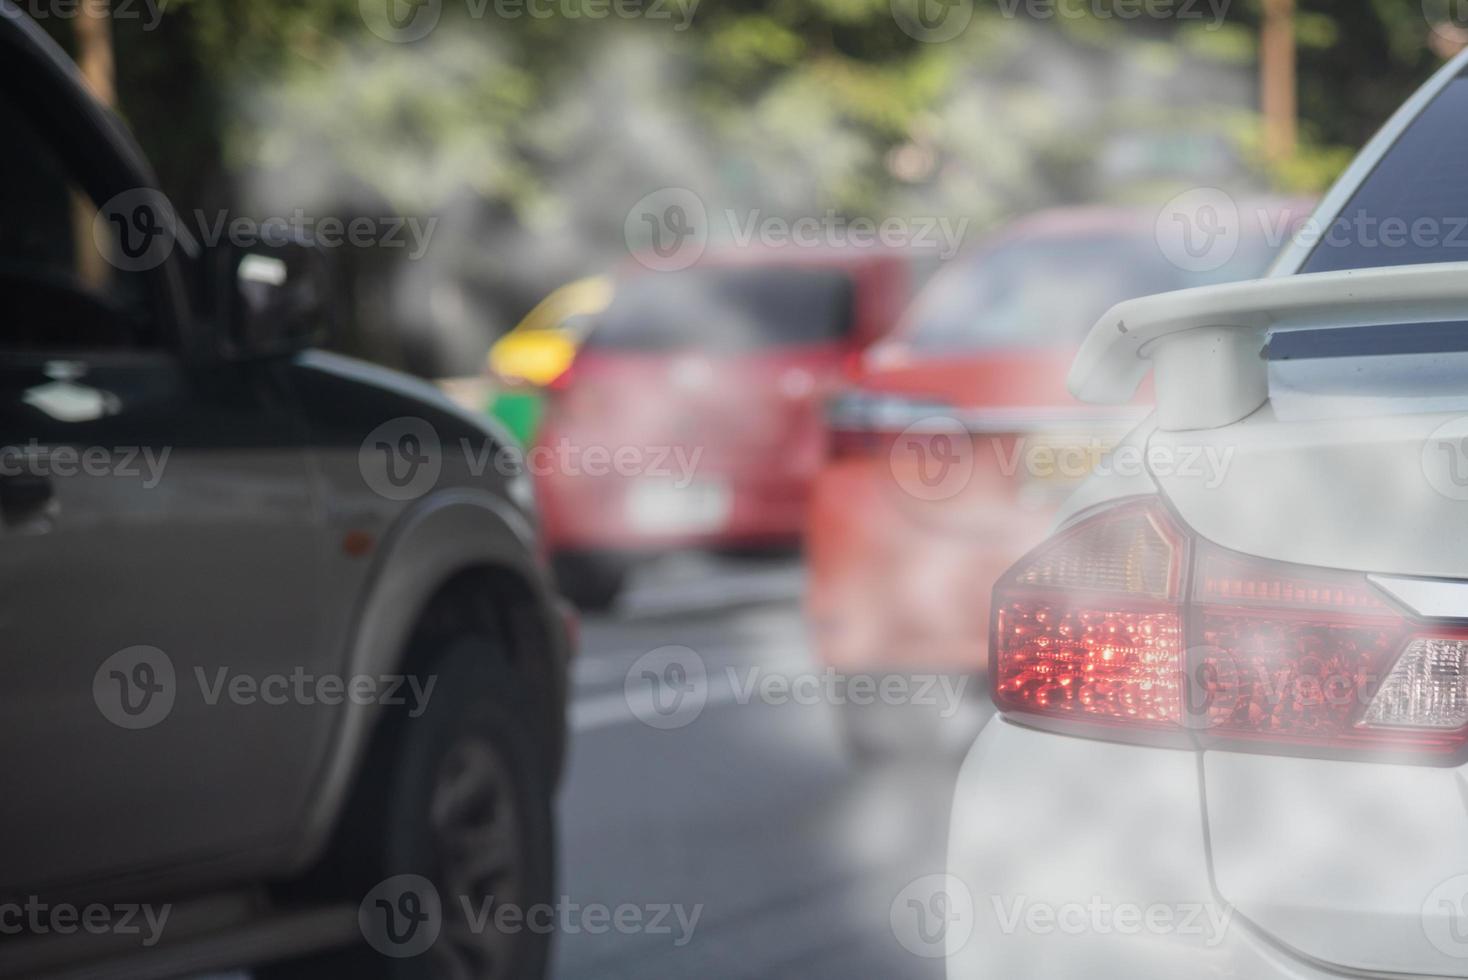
[948,717,1340,980]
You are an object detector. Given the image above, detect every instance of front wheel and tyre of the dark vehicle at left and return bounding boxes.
[260,638,555,980]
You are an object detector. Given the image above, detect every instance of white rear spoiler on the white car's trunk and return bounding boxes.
[1069,263,1468,430]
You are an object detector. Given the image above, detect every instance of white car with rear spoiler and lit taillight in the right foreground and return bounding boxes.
[951,44,1468,980]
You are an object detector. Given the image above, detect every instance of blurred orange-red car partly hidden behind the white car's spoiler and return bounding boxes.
[806,201,1309,748]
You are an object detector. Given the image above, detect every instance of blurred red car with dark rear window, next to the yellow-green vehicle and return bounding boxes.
[528,248,910,609]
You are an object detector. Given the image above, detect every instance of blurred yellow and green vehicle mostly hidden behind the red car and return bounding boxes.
[487,276,612,445]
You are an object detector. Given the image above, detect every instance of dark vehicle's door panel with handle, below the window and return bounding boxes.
[0,356,335,885]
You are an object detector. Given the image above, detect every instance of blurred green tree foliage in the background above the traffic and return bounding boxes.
[66,0,1442,369]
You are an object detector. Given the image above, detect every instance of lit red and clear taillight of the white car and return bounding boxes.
[991,500,1468,761]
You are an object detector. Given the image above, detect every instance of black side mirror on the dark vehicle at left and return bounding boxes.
[208,239,332,358]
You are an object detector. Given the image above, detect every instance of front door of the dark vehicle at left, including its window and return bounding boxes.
[0,26,341,893]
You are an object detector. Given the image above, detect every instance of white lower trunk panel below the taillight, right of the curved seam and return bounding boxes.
[1204,753,1468,977]
